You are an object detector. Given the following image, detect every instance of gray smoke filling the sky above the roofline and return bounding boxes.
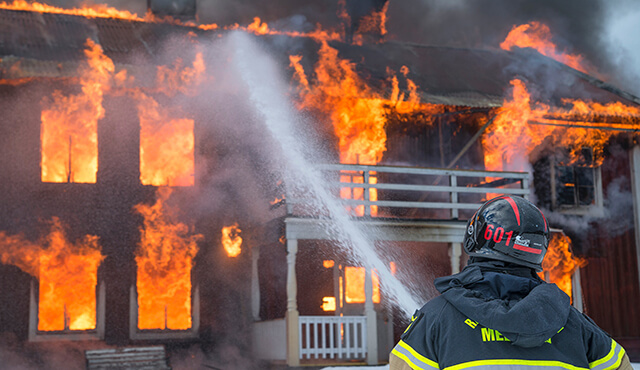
[37,0,640,94]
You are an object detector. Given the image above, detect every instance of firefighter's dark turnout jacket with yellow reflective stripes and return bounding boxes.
[390,262,631,370]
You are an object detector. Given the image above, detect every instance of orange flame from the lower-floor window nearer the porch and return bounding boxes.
[134,188,202,330]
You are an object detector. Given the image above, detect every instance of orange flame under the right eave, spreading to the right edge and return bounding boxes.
[482,79,640,171]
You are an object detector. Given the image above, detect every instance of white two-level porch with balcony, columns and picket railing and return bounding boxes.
[252,164,529,366]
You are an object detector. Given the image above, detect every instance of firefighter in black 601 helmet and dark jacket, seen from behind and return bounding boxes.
[389,195,632,370]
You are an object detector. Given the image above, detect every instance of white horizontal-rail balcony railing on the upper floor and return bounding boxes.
[285,164,530,219]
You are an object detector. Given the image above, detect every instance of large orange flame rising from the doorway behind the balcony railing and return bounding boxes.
[289,42,440,216]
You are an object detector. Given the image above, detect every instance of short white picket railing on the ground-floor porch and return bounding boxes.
[298,316,367,359]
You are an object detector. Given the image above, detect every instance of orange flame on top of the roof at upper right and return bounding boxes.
[500,22,587,73]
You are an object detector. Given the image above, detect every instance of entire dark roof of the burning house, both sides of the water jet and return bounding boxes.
[0,9,640,109]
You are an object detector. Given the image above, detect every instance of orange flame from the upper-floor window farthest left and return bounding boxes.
[41,39,114,183]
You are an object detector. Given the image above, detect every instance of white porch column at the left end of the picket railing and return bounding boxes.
[285,238,300,366]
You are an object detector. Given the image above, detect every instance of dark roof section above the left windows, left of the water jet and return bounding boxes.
[0,9,205,79]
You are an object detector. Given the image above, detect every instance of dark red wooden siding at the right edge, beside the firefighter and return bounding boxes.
[579,145,640,361]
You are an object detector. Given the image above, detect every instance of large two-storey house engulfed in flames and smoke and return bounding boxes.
[0,1,640,365]
